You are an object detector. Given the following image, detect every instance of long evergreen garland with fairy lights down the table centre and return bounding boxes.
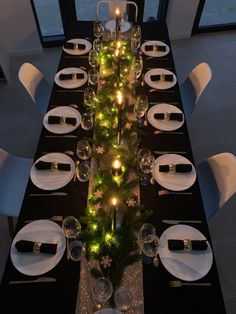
[80,40,151,287]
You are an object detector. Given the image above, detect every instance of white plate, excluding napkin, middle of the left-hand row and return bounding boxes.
[43,106,82,134]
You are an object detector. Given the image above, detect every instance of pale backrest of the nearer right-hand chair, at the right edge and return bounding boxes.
[207,152,236,207]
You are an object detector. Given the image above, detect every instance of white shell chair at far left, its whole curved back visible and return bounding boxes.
[18,62,51,115]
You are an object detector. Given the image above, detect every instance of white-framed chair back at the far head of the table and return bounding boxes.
[97,0,138,22]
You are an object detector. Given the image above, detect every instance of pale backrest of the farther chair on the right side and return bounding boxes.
[188,62,212,104]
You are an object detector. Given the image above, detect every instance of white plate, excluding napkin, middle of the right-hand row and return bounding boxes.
[147,103,184,131]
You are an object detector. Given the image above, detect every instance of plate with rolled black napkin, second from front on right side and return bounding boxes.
[152,153,197,191]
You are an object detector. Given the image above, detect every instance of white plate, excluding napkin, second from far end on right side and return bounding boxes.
[144,68,177,89]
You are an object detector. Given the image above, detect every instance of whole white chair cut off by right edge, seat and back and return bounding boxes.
[197,152,236,219]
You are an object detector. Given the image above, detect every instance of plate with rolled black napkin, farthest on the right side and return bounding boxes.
[140,40,170,58]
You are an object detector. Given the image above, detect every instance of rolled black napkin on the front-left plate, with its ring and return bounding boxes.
[15,240,57,254]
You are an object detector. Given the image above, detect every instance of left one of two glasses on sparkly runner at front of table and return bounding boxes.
[92,277,113,305]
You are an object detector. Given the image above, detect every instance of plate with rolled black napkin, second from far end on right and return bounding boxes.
[144,68,177,90]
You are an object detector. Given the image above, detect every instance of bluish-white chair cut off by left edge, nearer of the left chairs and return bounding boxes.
[0,148,33,236]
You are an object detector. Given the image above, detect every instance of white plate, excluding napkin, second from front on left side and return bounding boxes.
[30,153,75,190]
